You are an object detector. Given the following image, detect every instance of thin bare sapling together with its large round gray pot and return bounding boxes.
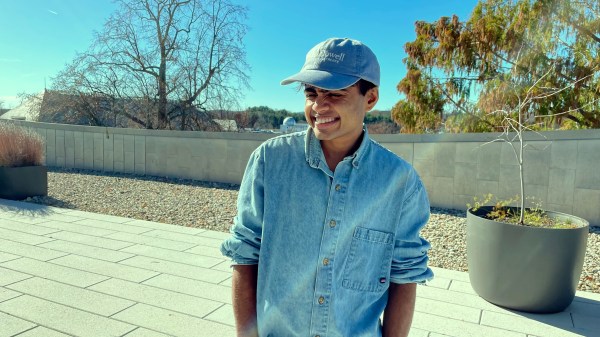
[467,65,589,313]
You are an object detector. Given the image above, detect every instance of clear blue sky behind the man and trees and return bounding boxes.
[0,0,477,112]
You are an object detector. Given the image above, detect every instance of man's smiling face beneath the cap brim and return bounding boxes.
[304,85,379,147]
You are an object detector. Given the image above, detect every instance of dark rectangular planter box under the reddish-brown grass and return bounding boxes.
[0,166,48,200]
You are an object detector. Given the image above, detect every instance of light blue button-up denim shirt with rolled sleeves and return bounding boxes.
[221,129,433,337]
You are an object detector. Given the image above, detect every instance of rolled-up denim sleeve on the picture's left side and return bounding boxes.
[221,147,264,265]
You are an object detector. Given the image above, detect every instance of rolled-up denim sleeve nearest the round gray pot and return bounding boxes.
[390,171,433,284]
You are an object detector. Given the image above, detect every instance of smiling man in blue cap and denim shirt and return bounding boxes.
[221,39,433,337]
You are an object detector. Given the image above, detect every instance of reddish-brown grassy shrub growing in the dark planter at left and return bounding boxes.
[0,122,44,167]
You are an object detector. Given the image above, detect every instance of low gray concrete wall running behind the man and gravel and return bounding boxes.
[5,121,600,226]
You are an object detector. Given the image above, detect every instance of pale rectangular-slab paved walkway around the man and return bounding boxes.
[0,199,600,337]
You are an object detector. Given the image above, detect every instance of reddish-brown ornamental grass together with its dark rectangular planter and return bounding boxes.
[0,122,48,200]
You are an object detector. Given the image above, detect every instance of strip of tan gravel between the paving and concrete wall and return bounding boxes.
[26,168,600,293]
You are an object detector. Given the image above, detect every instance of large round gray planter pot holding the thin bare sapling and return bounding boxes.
[467,206,589,313]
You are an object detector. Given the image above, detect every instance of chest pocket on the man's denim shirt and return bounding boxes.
[342,227,394,292]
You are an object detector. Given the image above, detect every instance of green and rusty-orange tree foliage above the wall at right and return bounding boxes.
[392,0,600,133]
